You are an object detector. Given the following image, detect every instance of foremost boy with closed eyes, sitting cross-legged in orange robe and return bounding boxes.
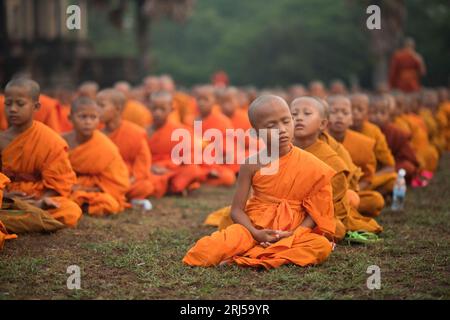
[183,95,336,269]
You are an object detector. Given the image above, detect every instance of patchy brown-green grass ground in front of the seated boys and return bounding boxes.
[0,154,450,299]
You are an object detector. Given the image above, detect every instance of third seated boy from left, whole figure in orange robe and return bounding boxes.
[97,89,155,200]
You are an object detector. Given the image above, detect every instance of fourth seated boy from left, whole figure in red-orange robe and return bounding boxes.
[147,91,203,196]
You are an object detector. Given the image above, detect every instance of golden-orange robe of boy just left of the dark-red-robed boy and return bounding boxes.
[360,121,397,194]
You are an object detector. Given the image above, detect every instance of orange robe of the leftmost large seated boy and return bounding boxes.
[2,121,81,227]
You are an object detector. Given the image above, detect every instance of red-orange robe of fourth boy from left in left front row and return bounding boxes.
[148,121,204,194]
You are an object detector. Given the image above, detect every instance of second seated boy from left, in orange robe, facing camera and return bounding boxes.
[64,97,130,216]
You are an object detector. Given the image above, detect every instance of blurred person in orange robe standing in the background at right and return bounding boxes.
[389,38,426,92]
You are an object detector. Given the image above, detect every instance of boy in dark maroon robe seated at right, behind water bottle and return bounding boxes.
[369,96,420,182]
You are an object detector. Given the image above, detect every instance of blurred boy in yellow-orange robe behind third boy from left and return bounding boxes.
[114,81,153,128]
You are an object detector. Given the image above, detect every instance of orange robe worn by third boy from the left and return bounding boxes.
[109,120,155,199]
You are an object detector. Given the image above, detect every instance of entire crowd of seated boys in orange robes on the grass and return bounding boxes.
[0,76,450,268]
